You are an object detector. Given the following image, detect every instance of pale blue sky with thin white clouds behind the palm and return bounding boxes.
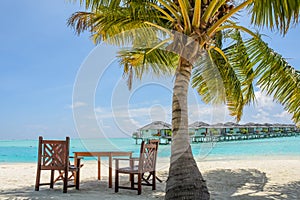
[0,0,300,139]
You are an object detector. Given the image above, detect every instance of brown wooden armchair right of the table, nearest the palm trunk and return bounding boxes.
[115,141,157,194]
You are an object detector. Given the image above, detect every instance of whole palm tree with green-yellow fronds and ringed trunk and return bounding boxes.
[68,0,300,199]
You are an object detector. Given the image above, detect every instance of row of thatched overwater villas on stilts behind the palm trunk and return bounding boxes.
[132,121,300,144]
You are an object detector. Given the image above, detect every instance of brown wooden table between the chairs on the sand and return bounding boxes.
[74,151,132,188]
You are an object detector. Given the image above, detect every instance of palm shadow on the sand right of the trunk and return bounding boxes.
[203,169,300,200]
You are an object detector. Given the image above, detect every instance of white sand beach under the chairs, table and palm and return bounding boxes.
[0,157,300,200]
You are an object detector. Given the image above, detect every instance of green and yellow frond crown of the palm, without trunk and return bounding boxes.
[68,0,300,123]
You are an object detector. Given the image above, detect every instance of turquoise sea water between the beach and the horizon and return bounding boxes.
[0,136,300,163]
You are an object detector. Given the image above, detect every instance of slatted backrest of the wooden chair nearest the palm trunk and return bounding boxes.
[139,141,158,173]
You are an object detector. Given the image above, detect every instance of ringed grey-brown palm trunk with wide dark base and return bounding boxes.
[165,58,209,200]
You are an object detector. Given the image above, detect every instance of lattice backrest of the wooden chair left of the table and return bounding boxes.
[38,136,70,170]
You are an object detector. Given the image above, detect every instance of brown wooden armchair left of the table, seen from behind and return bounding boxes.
[35,136,82,193]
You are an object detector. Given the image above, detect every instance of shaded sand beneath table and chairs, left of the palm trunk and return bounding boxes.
[0,179,164,200]
